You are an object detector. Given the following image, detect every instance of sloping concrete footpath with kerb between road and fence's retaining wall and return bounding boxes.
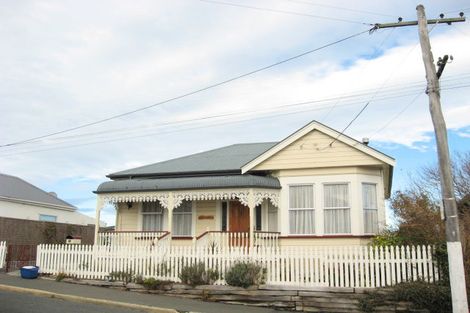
[0,273,279,313]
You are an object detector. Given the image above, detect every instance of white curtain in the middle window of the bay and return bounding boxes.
[324,184,351,234]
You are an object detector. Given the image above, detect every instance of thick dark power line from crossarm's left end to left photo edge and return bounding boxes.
[0,30,369,148]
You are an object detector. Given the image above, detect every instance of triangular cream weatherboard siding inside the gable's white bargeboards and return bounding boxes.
[253,130,384,170]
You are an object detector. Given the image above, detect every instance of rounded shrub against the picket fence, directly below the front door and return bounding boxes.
[225,262,265,288]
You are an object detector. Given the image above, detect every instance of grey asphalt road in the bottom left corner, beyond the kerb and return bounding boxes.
[0,291,149,313]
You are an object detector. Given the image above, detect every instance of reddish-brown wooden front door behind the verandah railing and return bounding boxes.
[229,201,250,246]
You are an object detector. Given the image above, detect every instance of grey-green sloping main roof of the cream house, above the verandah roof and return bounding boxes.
[108,142,277,178]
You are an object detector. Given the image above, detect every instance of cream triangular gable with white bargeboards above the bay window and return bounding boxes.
[242,121,395,173]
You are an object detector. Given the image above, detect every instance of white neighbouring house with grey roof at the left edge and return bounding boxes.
[0,174,95,225]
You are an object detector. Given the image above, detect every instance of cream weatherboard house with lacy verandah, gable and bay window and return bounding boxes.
[95,121,395,246]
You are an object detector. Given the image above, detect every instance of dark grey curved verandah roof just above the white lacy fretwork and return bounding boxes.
[96,174,281,193]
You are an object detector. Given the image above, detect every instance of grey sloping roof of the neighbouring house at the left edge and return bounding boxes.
[0,174,76,210]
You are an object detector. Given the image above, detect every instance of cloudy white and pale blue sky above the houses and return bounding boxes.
[0,0,470,224]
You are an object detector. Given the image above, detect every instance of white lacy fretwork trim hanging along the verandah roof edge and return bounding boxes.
[98,188,279,209]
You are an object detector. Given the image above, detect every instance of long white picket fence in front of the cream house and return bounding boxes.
[37,245,439,288]
